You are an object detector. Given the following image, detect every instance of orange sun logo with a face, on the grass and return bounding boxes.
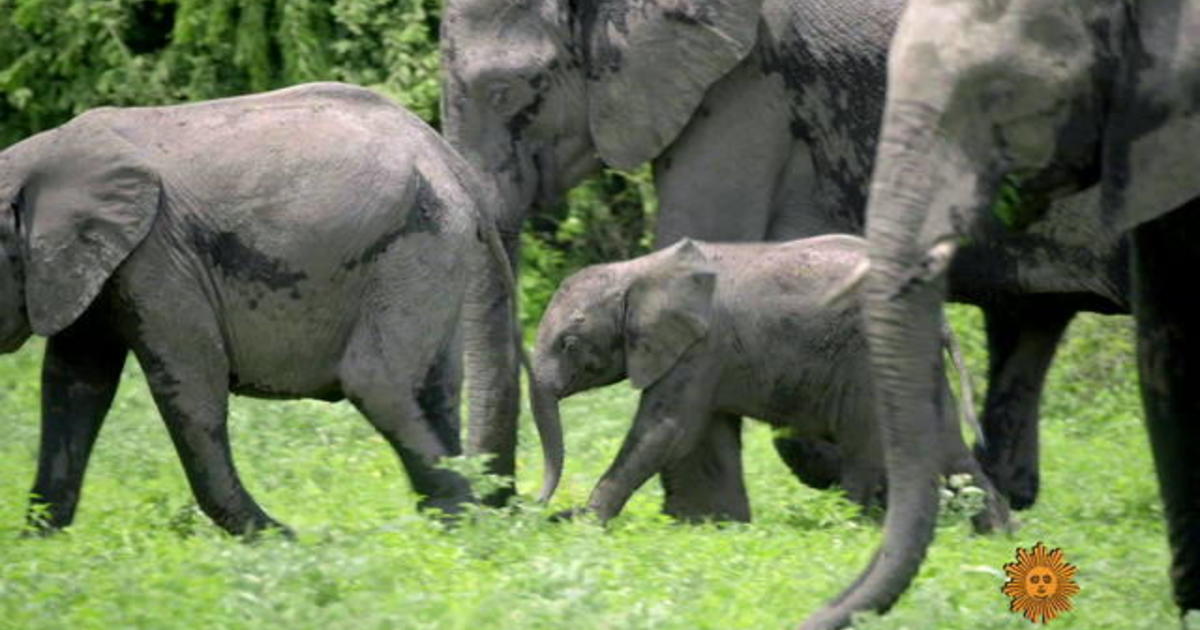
[1001,541,1079,623]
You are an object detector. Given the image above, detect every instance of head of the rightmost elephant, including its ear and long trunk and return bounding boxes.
[805,0,1200,628]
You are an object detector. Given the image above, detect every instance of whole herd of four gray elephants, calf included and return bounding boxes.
[0,0,1200,629]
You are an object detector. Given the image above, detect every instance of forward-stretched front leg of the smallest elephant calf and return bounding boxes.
[588,370,715,521]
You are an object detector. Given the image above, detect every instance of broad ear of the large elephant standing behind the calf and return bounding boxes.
[581,0,762,169]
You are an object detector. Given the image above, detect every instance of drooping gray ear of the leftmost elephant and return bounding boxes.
[22,119,161,336]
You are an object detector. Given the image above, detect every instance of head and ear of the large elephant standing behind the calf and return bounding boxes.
[442,0,761,218]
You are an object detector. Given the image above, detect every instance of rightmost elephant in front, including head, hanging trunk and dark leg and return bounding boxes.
[805,0,1200,629]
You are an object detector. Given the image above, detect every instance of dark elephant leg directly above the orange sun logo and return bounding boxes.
[976,299,1075,510]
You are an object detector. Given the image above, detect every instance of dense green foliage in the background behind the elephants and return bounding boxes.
[0,0,654,326]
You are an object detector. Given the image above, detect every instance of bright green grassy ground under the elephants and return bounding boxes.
[0,308,1174,630]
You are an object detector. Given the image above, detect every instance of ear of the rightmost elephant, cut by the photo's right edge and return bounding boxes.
[1103,0,1200,230]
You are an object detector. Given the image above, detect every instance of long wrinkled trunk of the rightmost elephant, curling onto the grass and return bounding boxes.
[803,103,976,630]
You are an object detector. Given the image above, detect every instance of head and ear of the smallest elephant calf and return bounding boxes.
[534,240,716,418]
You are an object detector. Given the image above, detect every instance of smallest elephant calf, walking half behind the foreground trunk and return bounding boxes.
[534,235,1008,530]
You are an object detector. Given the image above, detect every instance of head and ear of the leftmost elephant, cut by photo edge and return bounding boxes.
[0,116,161,352]
